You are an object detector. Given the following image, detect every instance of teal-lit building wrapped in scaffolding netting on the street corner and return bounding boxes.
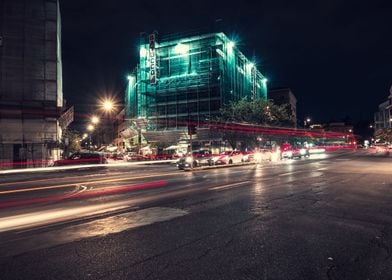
[125,33,267,131]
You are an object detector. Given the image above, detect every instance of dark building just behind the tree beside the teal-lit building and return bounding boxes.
[268,88,297,127]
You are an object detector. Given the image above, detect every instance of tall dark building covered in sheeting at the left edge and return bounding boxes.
[0,0,66,166]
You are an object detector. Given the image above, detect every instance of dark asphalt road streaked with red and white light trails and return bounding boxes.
[0,152,392,279]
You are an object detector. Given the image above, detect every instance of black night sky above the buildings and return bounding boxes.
[60,0,392,124]
